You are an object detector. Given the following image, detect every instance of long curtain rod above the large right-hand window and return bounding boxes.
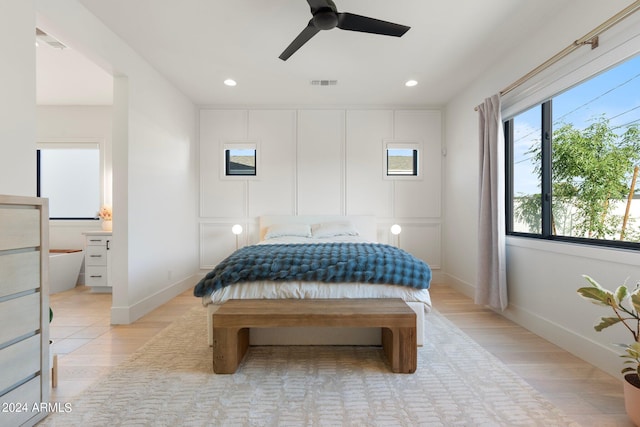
[474,0,640,111]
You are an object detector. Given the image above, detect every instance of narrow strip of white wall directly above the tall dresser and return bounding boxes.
[0,1,36,196]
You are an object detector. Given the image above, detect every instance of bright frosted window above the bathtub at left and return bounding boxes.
[36,143,101,219]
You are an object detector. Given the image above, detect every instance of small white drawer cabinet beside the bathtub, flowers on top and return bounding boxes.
[84,231,113,292]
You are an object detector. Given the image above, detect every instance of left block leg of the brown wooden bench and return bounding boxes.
[213,328,249,374]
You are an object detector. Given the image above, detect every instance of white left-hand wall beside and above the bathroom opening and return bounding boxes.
[31,0,198,323]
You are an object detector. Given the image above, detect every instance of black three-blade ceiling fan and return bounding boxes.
[279,0,411,61]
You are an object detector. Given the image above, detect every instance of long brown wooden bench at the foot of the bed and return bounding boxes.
[212,299,418,374]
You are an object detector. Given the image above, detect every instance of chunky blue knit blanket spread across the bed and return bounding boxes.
[193,243,431,297]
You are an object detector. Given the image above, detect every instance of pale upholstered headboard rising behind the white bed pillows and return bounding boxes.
[260,215,378,242]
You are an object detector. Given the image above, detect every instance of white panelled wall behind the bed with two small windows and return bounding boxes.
[200,109,442,270]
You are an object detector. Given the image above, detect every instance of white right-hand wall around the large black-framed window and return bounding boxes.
[443,0,640,376]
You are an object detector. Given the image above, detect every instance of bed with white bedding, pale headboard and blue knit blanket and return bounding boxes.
[194,216,431,345]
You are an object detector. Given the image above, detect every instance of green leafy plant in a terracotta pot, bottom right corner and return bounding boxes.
[578,275,640,426]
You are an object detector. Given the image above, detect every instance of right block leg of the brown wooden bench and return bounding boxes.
[382,328,418,374]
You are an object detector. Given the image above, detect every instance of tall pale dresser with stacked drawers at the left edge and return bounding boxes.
[0,196,50,426]
